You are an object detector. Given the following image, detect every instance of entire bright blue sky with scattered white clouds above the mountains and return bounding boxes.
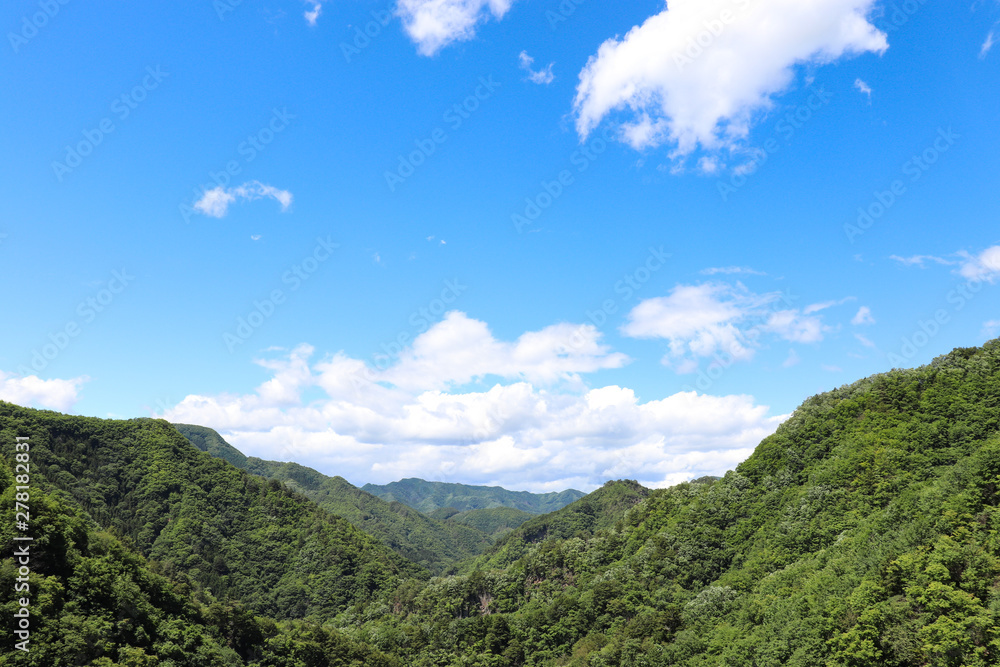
[0,0,1000,491]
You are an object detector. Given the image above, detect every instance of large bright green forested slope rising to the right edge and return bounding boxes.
[330,342,1000,667]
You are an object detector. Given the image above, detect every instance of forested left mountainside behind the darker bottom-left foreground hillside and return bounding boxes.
[0,402,423,618]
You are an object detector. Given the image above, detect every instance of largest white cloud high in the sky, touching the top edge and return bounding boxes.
[574,0,888,157]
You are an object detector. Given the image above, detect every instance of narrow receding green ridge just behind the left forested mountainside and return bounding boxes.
[174,424,493,573]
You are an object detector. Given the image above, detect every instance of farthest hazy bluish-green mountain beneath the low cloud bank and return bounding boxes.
[361,478,585,514]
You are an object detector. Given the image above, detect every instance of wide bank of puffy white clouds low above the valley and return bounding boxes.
[156,313,785,491]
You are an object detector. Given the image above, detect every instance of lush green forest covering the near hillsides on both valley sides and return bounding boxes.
[0,342,1000,667]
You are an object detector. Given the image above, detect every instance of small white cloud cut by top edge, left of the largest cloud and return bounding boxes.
[396,0,513,56]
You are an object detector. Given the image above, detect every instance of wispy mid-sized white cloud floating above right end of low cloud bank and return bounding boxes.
[622,282,834,373]
